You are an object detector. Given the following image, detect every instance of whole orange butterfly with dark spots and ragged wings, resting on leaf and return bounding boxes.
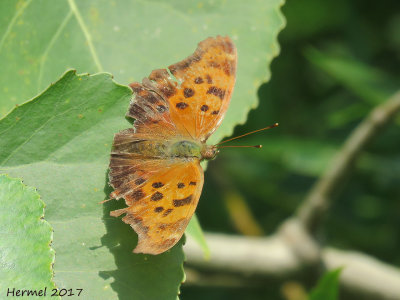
[109,36,237,255]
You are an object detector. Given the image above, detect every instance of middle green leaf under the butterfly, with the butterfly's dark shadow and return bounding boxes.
[0,71,184,299]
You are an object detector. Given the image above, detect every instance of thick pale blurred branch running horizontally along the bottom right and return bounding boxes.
[184,232,400,300]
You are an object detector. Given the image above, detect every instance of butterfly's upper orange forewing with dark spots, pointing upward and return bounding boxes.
[144,36,237,142]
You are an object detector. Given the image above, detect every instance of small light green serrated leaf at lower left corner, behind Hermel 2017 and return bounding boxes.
[0,174,58,299]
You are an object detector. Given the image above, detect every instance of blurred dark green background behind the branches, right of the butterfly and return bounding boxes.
[181,0,400,300]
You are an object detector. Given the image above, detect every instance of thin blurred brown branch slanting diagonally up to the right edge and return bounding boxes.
[297,91,400,232]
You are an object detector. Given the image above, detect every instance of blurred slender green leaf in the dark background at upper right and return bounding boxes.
[306,48,398,106]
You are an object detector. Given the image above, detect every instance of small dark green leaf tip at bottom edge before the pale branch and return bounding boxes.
[309,268,342,300]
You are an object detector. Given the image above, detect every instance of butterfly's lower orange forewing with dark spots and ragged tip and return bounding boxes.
[111,160,204,254]
